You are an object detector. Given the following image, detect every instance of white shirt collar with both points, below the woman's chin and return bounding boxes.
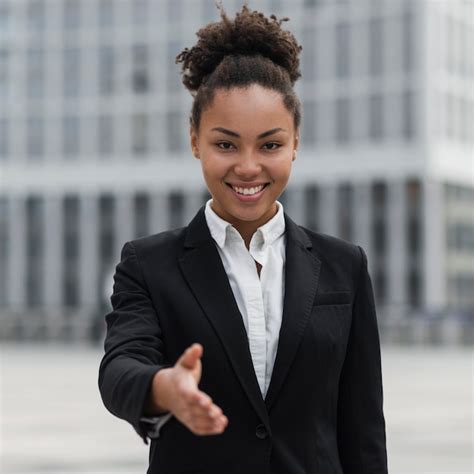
[204,198,285,248]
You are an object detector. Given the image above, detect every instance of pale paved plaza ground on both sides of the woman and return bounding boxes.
[0,344,474,474]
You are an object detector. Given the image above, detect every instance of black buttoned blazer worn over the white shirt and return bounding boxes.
[99,207,387,474]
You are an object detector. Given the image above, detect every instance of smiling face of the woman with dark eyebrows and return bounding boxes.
[191,84,299,231]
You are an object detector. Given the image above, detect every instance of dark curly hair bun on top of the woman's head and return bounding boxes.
[176,5,302,92]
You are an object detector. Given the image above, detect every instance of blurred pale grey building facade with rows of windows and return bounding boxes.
[0,0,474,337]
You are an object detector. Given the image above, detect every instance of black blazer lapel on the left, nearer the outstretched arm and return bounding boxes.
[179,207,270,430]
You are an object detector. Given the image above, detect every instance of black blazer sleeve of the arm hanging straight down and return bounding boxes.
[337,247,388,474]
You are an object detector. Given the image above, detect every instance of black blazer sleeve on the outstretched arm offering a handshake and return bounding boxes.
[99,242,169,443]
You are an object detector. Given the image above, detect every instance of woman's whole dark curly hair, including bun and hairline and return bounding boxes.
[176,4,302,130]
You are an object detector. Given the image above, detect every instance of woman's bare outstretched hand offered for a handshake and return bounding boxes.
[151,343,228,435]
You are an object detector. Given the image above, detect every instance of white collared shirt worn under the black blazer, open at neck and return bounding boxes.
[141,199,286,438]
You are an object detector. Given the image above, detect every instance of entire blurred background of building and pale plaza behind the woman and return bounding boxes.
[0,0,474,474]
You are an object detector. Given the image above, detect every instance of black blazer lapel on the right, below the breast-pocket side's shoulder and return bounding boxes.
[265,213,321,411]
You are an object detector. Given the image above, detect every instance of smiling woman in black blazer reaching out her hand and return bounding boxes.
[99,6,387,474]
